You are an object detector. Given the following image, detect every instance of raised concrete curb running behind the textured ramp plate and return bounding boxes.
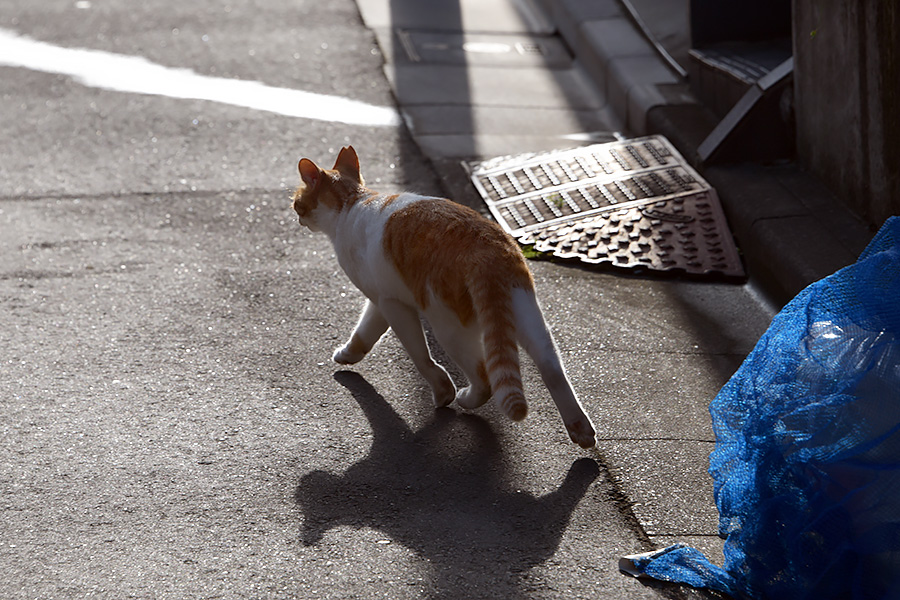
[537,0,873,304]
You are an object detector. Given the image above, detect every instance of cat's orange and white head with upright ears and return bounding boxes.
[293,146,365,231]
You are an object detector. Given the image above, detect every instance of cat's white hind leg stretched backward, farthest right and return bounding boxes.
[512,288,596,448]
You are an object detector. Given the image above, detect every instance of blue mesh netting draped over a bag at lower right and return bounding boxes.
[631,217,900,600]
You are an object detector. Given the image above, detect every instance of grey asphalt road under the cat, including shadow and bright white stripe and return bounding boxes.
[0,0,767,598]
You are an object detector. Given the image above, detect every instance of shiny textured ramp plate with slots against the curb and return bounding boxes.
[466,136,744,278]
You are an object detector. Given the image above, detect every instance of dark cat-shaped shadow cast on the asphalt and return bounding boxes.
[296,371,600,597]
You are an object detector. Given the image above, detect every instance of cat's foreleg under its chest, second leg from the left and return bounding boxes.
[379,299,456,408]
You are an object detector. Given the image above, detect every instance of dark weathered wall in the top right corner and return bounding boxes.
[793,0,900,226]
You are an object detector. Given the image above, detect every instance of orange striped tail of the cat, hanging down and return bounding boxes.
[470,277,528,421]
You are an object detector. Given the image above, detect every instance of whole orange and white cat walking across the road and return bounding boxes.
[293,146,595,448]
